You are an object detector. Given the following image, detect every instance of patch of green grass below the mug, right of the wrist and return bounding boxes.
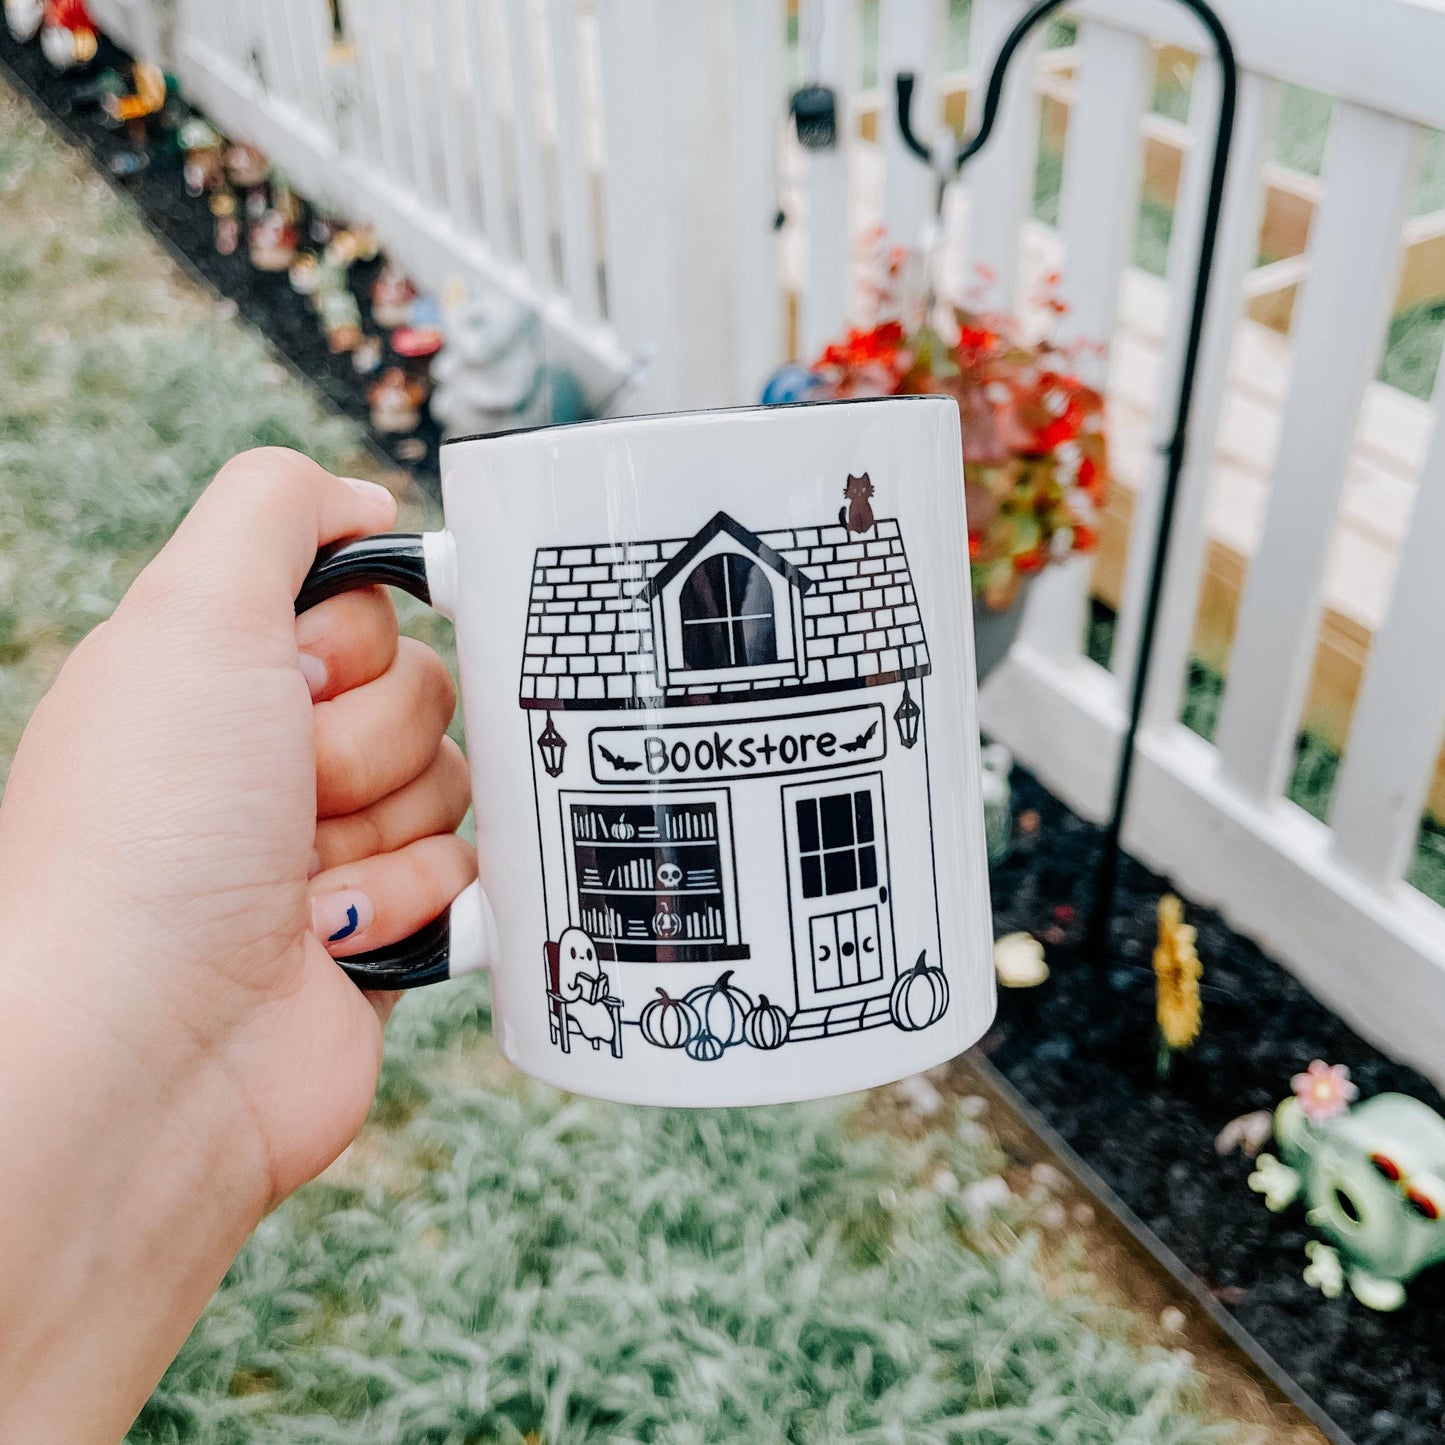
[131,984,1237,1445]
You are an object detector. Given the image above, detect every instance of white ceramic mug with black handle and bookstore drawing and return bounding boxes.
[298,397,994,1105]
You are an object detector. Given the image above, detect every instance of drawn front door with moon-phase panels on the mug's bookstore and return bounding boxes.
[783,773,897,1012]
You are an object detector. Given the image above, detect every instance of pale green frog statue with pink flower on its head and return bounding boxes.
[1250,1064,1445,1309]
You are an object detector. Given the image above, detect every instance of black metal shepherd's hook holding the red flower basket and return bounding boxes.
[897,0,1238,971]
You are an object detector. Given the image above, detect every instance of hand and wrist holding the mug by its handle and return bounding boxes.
[0,449,475,1439]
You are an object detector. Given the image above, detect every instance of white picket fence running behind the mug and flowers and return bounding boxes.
[92,0,1445,1081]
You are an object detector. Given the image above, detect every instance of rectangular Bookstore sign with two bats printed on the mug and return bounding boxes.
[588,702,887,786]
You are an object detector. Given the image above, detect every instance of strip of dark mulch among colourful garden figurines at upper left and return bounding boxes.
[0,25,441,496]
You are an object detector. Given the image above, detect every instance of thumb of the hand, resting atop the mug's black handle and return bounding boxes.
[137,447,396,626]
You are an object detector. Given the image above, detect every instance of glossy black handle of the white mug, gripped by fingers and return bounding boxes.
[296,532,494,988]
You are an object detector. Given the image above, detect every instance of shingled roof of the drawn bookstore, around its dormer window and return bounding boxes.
[520,513,932,709]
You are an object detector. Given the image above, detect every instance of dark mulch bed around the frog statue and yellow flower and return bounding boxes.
[983,770,1445,1445]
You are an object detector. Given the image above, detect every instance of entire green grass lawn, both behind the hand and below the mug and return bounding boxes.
[0,76,1259,1445]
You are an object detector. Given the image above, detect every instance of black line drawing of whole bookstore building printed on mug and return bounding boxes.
[519,485,949,1061]
